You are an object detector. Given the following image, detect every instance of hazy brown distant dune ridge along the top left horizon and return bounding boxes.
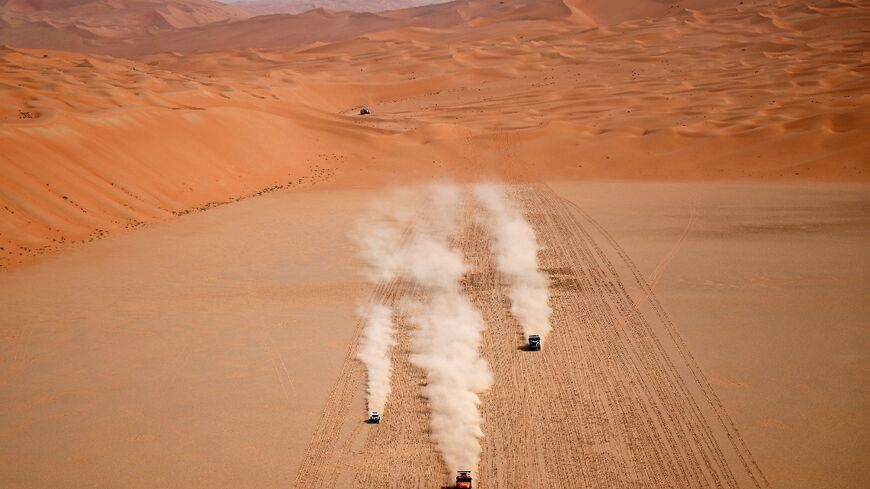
[0,0,571,57]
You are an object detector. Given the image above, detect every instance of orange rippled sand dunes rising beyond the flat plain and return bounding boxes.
[0,1,870,267]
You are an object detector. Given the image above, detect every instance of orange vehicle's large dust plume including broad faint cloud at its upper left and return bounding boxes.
[358,184,492,471]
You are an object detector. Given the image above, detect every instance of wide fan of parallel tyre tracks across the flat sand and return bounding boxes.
[295,185,770,489]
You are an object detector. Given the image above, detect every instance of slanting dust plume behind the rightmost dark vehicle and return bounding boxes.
[474,184,552,338]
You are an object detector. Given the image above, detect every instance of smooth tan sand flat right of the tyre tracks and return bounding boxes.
[551,182,870,488]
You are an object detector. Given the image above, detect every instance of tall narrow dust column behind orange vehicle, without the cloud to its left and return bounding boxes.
[407,183,493,472]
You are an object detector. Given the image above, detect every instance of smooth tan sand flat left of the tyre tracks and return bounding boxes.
[0,192,374,488]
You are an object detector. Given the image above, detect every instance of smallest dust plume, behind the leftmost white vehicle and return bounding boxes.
[356,304,395,413]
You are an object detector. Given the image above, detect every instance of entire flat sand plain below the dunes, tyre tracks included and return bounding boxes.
[0,181,870,489]
